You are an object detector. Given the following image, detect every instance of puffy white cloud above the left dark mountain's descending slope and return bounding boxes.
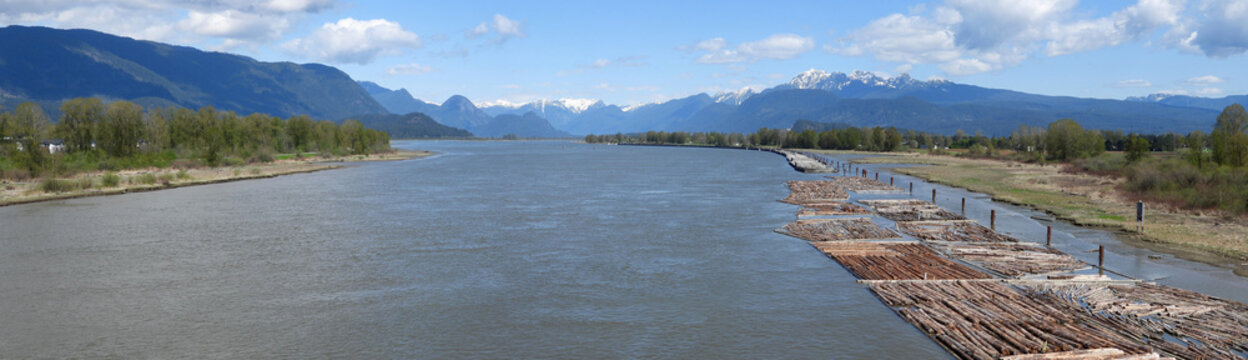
[282,18,422,65]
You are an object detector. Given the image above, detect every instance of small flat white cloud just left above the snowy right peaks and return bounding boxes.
[694,34,815,64]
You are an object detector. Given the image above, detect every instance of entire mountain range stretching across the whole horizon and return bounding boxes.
[0,26,1233,138]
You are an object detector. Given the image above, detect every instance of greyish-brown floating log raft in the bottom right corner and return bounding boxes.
[1025,283,1248,359]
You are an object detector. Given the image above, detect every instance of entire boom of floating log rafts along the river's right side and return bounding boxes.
[776,171,1248,359]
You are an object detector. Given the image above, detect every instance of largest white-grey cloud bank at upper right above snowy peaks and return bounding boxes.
[824,0,1184,75]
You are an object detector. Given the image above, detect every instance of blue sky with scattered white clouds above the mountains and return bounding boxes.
[0,0,1248,105]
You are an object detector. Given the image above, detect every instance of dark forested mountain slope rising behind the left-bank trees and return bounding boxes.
[0,25,387,119]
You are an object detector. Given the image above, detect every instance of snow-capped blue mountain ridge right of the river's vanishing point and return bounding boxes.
[386,69,1228,135]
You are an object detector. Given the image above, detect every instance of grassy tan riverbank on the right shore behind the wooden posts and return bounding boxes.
[838,154,1248,268]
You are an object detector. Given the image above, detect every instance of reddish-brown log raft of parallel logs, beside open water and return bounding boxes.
[814,241,992,280]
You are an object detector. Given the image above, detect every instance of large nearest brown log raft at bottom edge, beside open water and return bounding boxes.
[870,281,1152,359]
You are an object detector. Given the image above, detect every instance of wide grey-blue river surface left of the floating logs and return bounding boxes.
[0,141,947,359]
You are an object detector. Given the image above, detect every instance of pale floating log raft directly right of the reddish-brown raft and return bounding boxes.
[929,242,1088,278]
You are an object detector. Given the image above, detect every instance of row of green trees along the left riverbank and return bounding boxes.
[0,98,389,179]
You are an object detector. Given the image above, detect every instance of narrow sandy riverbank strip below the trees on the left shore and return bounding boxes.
[0,150,433,206]
